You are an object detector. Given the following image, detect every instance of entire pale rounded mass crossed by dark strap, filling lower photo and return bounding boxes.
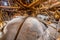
[2,17,60,40]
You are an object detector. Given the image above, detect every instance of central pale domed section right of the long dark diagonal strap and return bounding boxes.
[16,17,45,40]
